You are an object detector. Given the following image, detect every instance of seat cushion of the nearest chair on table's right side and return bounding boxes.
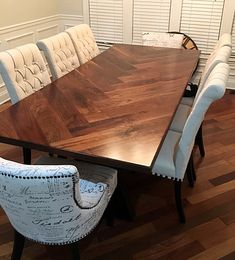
[152,130,181,179]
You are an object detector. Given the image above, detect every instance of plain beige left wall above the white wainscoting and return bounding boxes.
[0,0,59,28]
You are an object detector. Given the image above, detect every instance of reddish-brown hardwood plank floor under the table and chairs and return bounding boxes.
[0,90,235,260]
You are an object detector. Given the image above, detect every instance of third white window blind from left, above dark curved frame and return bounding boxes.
[180,0,224,71]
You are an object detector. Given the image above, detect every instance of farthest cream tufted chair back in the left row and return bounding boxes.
[66,24,100,64]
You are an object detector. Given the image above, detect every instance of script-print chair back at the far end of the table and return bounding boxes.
[142,32,184,49]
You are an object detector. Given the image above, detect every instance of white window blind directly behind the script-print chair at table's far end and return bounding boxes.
[133,0,171,44]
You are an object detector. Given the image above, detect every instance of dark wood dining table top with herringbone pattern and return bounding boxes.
[0,44,199,171]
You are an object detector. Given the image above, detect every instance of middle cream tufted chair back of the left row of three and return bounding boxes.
[37,32,80,80]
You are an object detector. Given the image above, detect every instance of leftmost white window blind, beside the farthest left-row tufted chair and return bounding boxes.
[89,0,123,43]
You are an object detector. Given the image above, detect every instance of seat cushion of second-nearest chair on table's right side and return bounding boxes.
[170,104,191,133]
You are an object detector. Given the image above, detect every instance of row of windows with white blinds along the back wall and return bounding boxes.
[83,0,235,88]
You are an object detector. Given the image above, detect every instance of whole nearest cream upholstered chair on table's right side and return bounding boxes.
[152,63,229,222]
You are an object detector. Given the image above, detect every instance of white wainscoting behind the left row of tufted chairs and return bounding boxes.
[0,14,83,104]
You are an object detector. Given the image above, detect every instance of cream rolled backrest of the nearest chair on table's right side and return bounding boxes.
[175,63,229,179]
